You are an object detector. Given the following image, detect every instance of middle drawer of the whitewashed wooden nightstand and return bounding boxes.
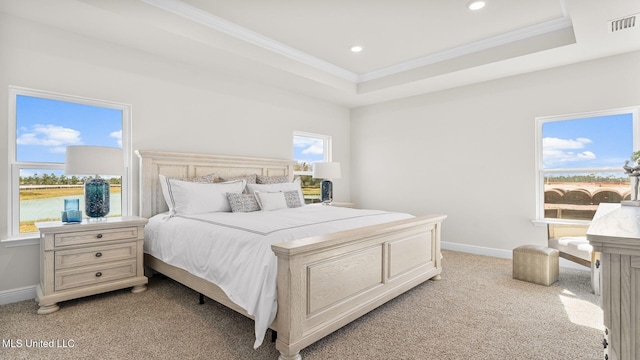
[55,242,137,270]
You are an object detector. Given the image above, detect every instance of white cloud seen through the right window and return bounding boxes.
[542,138,597,166]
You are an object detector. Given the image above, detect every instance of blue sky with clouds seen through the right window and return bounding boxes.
[542,113,633,171]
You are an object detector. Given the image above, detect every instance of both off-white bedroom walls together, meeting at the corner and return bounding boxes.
[0,10,640,297]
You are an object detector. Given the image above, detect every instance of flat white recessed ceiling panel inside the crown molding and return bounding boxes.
[174,0,565,75]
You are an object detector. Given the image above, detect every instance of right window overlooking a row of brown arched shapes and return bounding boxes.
[536,108,640,222]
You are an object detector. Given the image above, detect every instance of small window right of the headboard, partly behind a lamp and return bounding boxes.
[293,131,331,204]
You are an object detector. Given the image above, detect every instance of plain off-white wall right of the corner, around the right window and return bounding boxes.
[351,52,640,255]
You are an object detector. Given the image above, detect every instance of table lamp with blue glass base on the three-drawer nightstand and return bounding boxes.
[64,146,124,218]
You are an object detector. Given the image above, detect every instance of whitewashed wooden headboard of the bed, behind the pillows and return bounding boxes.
[136,150,296,218]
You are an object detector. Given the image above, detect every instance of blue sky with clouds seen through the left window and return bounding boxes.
[16,95,122,163]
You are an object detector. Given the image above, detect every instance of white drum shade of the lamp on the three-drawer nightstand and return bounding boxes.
[64,146,124,176]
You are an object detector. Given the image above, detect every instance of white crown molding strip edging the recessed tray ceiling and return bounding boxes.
[142,0,572,84]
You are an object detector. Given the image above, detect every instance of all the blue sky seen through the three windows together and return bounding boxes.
[16,95,633,174]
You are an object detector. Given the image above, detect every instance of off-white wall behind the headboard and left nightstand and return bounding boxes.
[0,14,350,294]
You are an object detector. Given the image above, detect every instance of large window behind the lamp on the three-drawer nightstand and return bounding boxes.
[9,87,130,237]
